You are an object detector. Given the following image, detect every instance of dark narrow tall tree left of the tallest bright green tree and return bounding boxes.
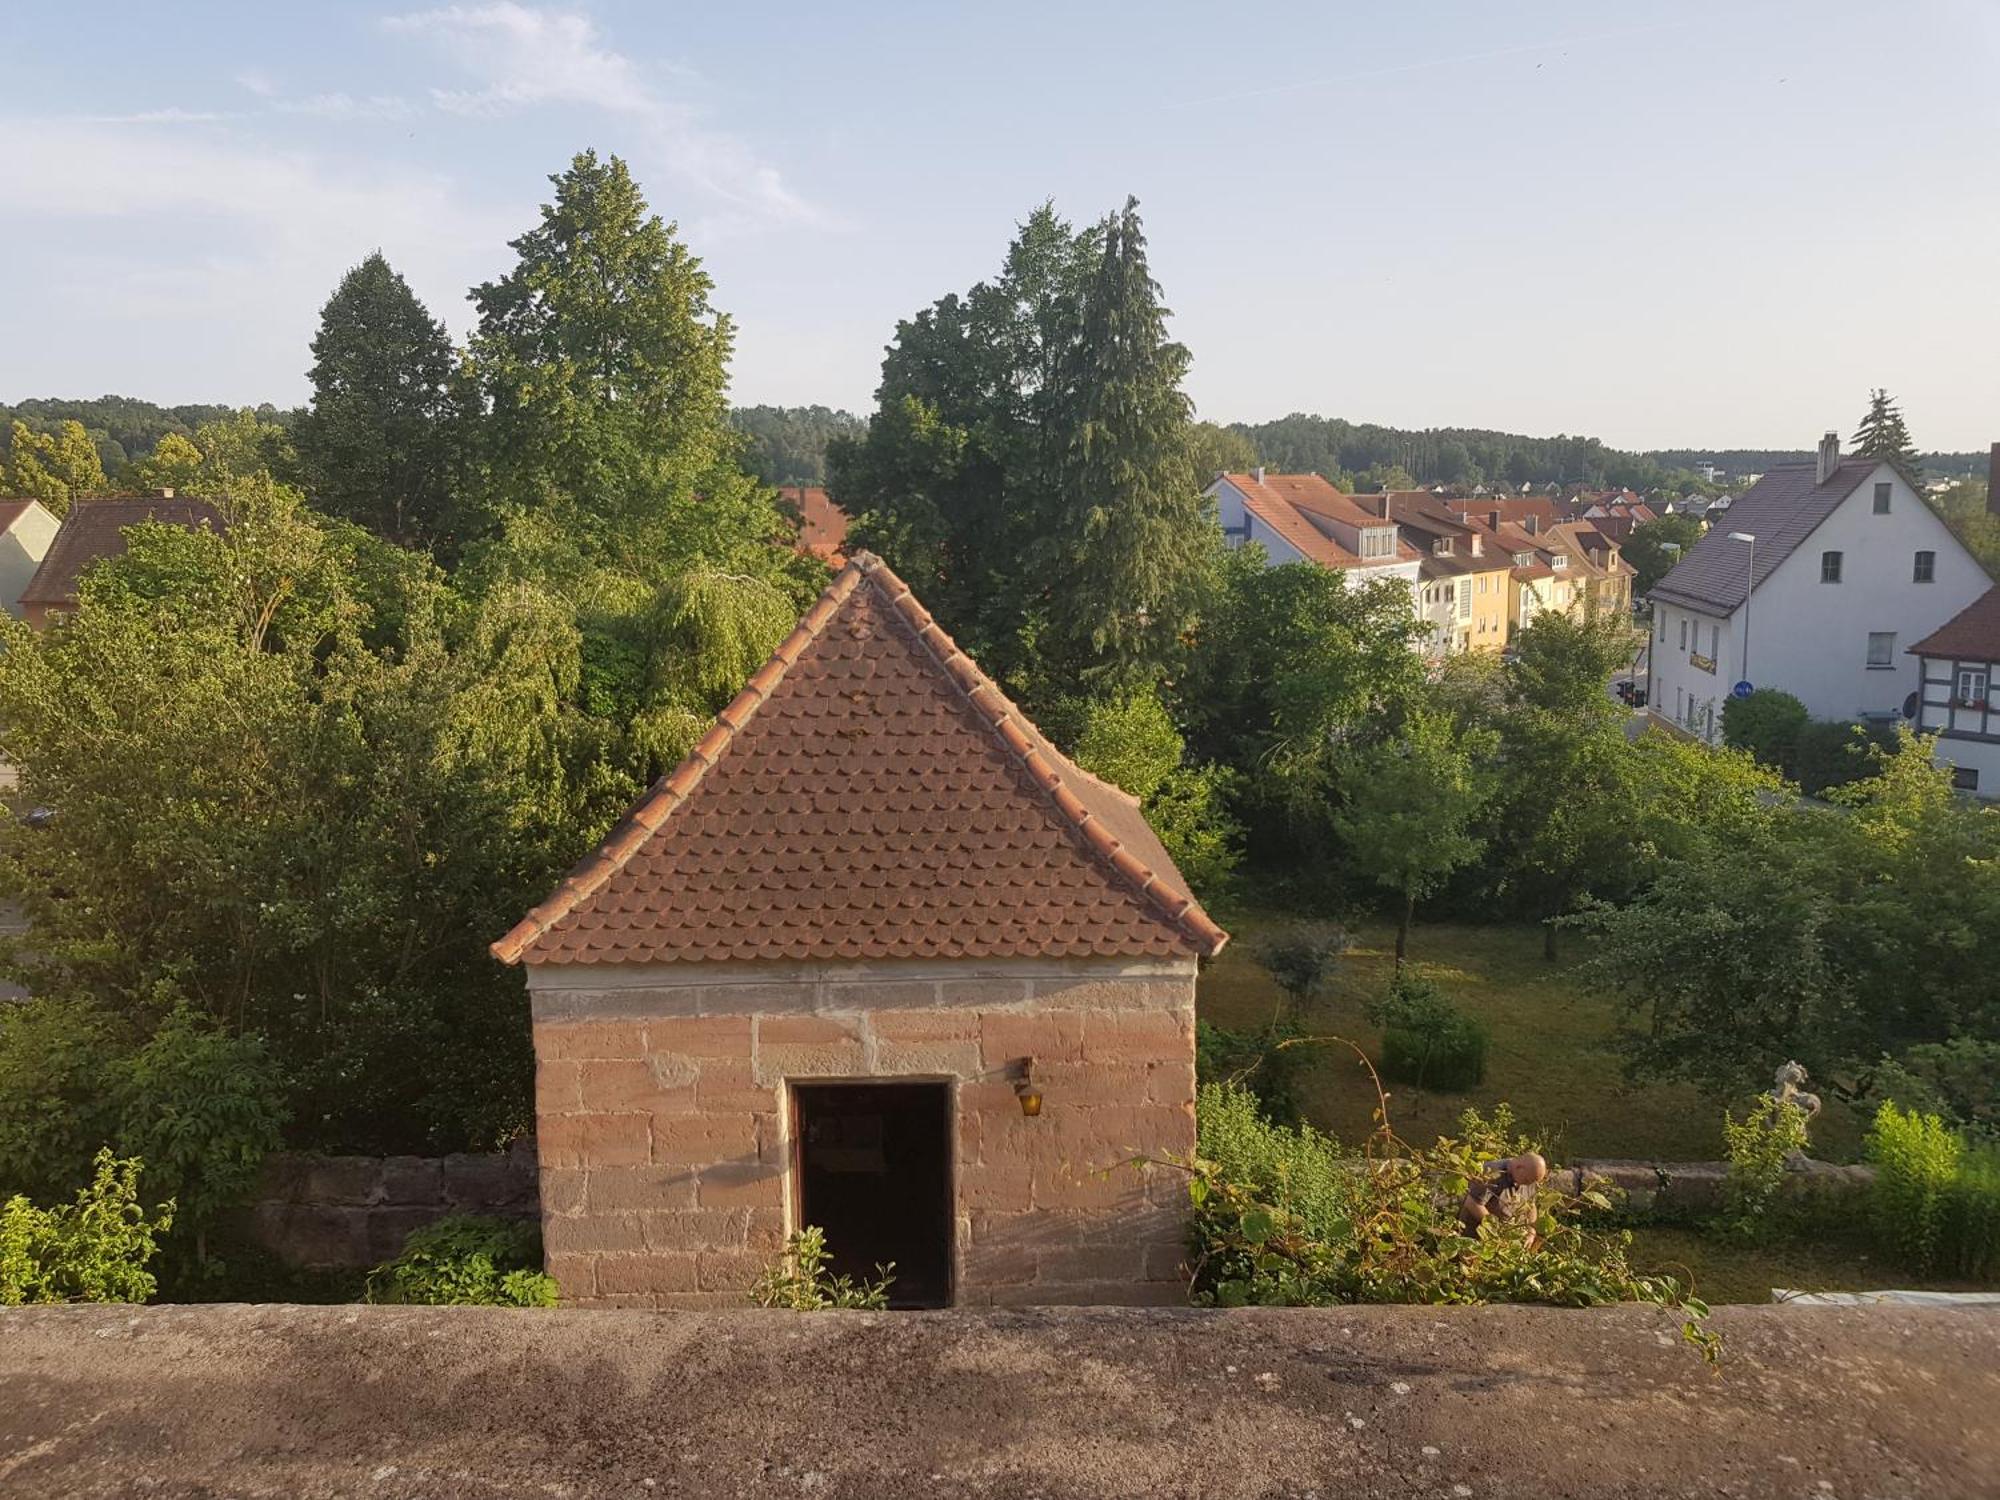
[294,252,456,550]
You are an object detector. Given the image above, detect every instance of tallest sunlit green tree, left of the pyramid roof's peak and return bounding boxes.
[472,152,784,576]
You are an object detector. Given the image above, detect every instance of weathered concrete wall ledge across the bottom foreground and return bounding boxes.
[0,1306,2000,1500]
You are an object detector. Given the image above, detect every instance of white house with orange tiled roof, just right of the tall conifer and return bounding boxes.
[1208,468,1424,610]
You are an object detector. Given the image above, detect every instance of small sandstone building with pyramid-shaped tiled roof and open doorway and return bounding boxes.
[494,552,1226,1308]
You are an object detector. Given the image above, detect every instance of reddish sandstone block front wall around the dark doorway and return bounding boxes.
[530,960,1194,1308]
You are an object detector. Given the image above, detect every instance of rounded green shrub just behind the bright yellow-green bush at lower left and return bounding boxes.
[112,1008,286,1262]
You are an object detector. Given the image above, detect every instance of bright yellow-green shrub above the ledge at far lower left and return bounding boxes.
[0,1150,174,1308]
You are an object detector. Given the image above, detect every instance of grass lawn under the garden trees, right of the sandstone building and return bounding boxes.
[1198,910,1860,1162]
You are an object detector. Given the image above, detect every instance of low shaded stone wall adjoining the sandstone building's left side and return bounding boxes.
[248,1140,542,1270]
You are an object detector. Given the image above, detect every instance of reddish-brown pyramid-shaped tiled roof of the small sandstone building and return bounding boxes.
[492,552,1228,964]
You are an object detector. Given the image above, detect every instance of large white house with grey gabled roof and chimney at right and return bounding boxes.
[1648,432,1992,744]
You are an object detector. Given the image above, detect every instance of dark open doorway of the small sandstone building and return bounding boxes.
[792,1084,952,1308]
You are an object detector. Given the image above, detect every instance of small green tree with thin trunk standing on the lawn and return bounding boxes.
[1334,708,1500,964]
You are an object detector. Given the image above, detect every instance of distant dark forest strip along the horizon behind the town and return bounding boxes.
[0,396,1986,492]
